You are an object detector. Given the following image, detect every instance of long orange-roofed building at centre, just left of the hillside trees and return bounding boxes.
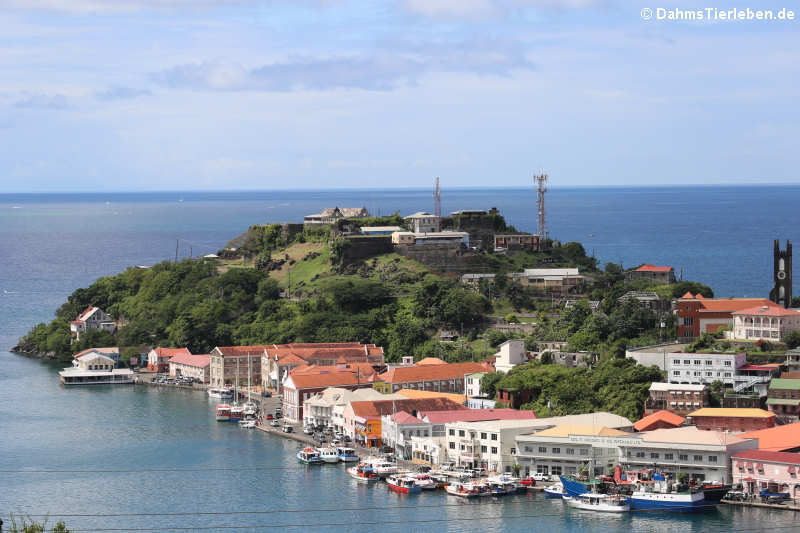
[375,363,491,394]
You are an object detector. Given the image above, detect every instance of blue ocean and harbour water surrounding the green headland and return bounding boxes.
[0,186,800,533]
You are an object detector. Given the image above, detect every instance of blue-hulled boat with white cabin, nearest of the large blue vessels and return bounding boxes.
[628,475,717,513]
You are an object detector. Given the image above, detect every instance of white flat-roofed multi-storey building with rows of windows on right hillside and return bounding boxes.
[666,352,748,387]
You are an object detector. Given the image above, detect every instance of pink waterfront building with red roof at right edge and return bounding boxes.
[731,450,800,502]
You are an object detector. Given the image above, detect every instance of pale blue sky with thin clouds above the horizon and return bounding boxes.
[0,0,800,192]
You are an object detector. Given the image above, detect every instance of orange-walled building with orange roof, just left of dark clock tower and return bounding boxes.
[676,292,777,342]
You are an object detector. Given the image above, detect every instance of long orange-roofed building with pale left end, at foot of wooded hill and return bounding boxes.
[259,342,385,393]
